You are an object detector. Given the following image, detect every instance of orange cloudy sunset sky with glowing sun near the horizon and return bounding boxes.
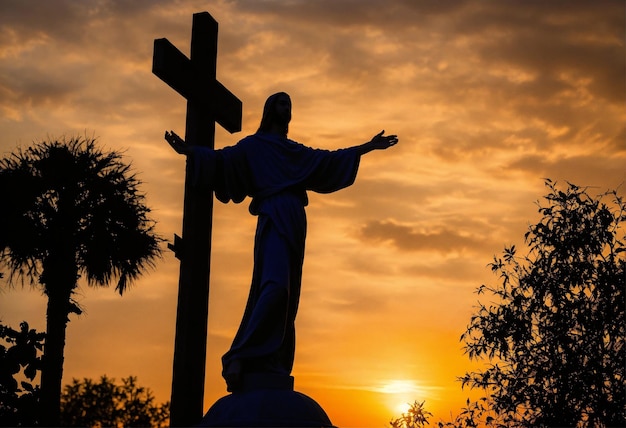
[0,0,626,427]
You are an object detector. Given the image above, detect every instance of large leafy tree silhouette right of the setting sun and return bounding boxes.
[461,180,626,426]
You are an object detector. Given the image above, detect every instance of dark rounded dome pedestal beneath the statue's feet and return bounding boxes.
[199,374,333,427]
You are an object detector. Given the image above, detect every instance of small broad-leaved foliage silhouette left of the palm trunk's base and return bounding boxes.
[0,321,45,427]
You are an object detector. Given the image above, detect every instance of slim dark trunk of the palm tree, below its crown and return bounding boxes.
[39,264,76,427]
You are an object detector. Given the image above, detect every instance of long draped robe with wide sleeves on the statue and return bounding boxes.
[188,132,360,390]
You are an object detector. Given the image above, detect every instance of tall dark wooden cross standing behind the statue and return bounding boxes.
[152,12,241,427]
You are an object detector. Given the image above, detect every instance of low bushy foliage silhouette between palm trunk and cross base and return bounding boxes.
[61,376,169,427]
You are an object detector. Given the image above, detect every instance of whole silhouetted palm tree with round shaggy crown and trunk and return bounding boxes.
[0,138,162,426]
